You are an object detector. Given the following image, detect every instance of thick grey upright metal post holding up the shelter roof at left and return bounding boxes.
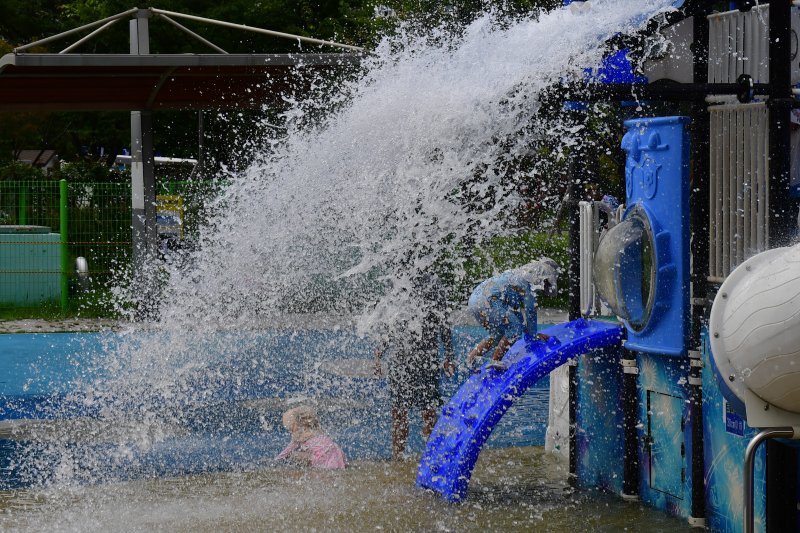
[130,9,158,317]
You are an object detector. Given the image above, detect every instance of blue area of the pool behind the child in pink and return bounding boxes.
[0,326,548,489]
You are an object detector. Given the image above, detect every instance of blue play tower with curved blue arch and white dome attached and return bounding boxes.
[417,0,800,533]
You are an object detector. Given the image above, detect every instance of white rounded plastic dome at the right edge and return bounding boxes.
[709,245,800,422]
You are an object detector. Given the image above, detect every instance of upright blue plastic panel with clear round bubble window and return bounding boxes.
[598,117,690,356]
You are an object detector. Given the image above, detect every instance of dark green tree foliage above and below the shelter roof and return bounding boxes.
[0,0,561,178]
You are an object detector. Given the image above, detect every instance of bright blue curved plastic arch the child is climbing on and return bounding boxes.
[417,319,623,501]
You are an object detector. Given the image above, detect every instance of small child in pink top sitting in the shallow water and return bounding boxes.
[275,406,346,470]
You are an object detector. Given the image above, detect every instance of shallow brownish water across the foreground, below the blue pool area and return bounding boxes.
[0,447,690,533]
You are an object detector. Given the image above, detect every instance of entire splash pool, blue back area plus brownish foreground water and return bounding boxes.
[0,327,689,533]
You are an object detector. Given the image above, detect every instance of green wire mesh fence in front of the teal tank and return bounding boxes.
[0,180,224,316]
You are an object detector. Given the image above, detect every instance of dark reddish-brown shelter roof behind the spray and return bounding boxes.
[0,53,362,111]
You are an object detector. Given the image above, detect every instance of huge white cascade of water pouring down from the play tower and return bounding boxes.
[0,0,692,528]
